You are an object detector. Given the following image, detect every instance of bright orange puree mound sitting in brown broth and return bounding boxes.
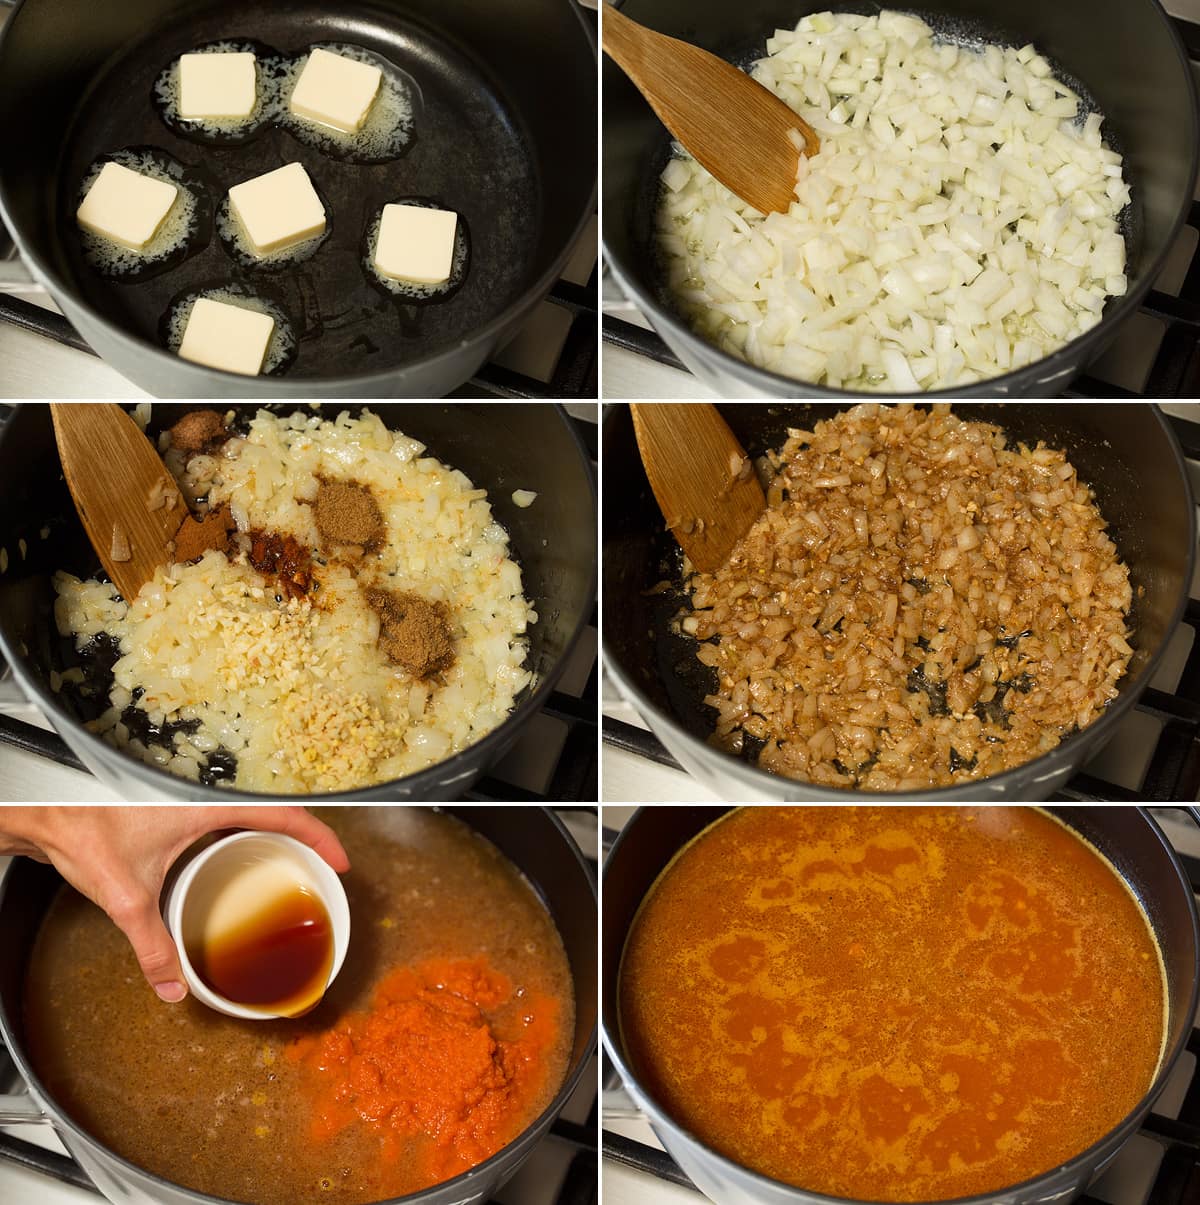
[288,958,558,1192]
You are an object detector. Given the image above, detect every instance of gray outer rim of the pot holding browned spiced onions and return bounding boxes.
[604,394,1198,803]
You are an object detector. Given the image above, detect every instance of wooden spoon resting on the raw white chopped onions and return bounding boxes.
[602,5,820,213]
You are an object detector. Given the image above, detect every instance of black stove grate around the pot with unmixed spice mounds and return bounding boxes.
[0,409,600,804]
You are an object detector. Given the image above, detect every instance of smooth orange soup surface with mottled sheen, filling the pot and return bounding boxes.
[620,807,1165,1201]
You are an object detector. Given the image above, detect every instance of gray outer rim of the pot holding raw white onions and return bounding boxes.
[601,0,1200,401]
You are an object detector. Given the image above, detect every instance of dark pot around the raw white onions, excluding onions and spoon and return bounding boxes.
[602,0,1200,398]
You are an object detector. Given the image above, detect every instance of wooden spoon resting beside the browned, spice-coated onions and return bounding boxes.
[630,401,766,574]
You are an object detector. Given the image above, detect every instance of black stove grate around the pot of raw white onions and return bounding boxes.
[602,17,1200,398]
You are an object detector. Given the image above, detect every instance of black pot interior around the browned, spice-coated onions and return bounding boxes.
[604,402,1195,794]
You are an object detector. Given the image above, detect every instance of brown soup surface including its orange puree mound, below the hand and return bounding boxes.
[25,807,575,1205]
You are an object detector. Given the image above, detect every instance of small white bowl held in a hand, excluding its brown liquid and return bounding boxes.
[163,831,349,1021]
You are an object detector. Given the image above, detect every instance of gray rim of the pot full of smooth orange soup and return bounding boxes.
[601,804,1200,1205]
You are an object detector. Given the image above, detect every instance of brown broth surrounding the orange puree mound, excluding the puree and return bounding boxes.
[25,807,573,1205]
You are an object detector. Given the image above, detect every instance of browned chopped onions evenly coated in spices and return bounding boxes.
[682,404,1133,790]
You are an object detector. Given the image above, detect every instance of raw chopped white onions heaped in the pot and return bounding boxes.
[658,12,1129,393]
